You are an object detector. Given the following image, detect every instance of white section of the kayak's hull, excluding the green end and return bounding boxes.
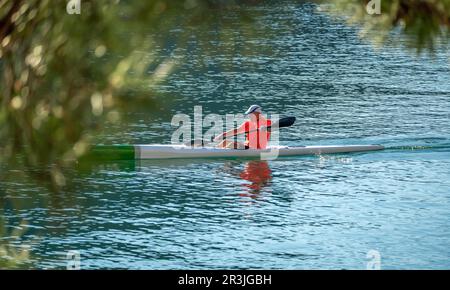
[134,145,384,159]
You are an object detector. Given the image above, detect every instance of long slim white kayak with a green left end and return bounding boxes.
[91,145,384,160]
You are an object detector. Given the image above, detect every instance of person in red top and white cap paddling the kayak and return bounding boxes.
[214,105,272,149]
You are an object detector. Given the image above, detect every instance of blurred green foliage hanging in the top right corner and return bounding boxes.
[319,0,450,53]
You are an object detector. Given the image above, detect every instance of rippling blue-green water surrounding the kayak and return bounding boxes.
[1,4,450,269]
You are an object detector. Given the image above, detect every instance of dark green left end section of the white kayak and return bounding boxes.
[83,145,136,160]
